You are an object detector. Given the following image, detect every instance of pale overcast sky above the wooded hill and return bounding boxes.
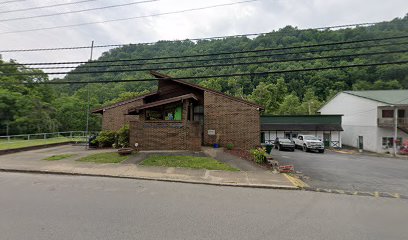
[0,0,408,67]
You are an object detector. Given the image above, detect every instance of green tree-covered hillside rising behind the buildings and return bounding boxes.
[0,15,408,135]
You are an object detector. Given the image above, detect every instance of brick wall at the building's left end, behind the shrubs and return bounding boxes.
[102,99,143,131]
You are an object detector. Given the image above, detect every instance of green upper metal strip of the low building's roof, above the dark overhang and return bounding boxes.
[261,115,343,124]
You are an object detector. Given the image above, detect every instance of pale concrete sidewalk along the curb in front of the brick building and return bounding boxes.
[0,146,298,189]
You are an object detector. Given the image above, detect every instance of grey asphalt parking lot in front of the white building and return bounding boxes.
[272,149,408,196]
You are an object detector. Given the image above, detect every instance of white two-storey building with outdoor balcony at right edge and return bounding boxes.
[319,90,408,153]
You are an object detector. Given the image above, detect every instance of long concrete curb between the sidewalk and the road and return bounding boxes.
[0,168,301,190]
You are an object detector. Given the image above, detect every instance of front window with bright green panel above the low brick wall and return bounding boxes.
[145,104,183,121]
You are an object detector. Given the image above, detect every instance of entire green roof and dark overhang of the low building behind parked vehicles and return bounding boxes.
[261,115,343,131]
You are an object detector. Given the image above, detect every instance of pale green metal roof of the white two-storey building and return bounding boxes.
[344,89,408,105]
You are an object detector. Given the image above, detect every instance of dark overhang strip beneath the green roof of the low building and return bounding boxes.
[261,123,343,131]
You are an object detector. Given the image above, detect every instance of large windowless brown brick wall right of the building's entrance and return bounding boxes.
[204,91,260,149]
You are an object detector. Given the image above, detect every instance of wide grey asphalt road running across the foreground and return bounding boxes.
[0,172,408,240]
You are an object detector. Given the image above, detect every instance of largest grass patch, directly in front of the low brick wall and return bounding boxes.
[141,156,239,171]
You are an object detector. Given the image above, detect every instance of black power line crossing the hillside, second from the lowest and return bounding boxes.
[4,50,408,76]
